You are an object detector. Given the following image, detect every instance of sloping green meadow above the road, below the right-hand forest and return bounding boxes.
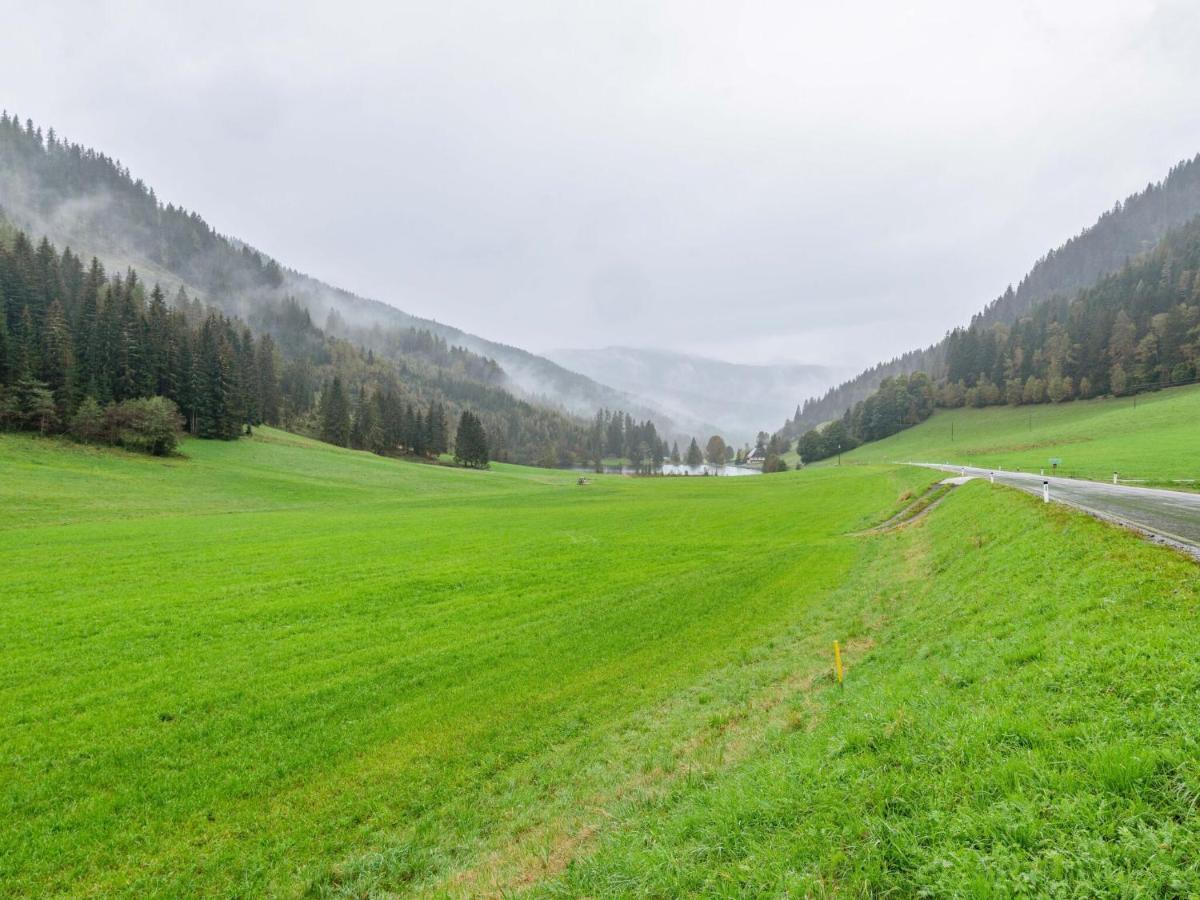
[825,385,1200,488]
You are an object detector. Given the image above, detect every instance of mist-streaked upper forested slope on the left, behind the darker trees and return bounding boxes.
[0,114,672,441]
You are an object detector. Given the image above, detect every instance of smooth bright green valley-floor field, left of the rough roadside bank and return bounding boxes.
[0,430,931,895]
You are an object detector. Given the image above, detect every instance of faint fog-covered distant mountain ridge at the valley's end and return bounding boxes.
[546,347,839,444]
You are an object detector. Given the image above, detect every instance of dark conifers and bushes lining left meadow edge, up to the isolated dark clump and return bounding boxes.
[0,229,488,466]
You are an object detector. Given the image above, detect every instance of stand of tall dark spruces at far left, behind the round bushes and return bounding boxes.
[0,232,280,448]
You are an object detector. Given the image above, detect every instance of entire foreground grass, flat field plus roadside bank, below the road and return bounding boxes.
[0,430,1200,896]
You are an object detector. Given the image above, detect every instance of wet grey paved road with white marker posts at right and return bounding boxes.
[917,463,1200,556]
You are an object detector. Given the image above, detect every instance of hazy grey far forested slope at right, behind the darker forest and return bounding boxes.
[782,156,1200,438]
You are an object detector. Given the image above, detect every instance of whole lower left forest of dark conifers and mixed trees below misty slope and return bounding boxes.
[0,222,662,464]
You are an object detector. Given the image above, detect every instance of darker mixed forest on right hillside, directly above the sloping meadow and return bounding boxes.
[799,218,1200,461]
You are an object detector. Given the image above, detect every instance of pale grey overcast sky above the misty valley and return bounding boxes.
[0,0,1200,365]
